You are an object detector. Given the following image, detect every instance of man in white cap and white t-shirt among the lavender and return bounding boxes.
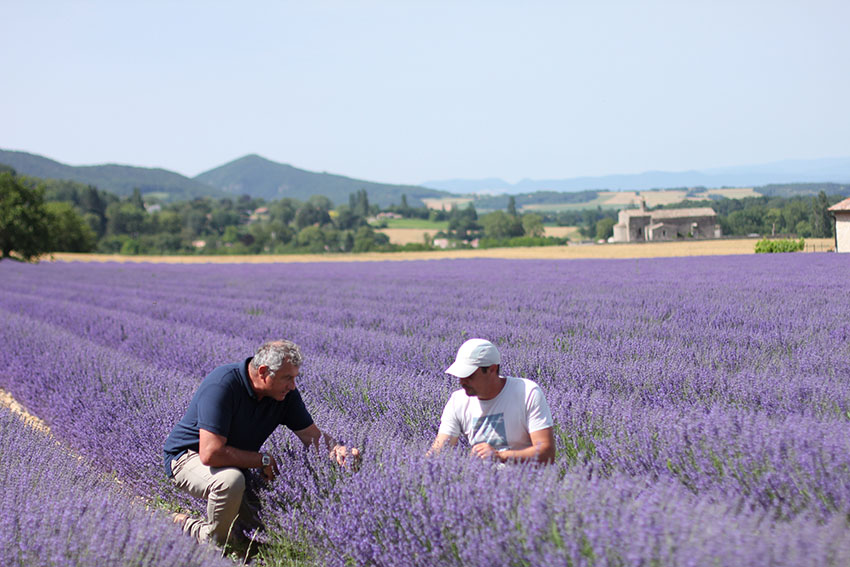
[429,339,555,463]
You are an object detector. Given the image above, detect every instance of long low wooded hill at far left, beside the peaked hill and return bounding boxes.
[0,150,225,201]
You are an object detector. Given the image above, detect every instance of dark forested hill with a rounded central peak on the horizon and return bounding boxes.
[195,155,450,207]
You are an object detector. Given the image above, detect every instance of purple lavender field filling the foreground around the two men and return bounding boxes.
[0,254,850,566]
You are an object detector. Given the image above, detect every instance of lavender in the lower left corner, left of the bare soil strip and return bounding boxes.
[0,408,232,567]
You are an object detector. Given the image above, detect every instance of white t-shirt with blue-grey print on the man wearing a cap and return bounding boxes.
[440,376,553,450]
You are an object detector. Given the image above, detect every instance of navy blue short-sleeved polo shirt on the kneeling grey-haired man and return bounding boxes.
[163,358,313,477]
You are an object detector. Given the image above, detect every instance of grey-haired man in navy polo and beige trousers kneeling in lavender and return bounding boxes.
[164,340,360,544]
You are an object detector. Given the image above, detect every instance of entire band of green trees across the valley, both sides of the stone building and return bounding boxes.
[0,166,843,259]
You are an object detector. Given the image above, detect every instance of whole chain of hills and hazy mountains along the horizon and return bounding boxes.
[0,149,850,207]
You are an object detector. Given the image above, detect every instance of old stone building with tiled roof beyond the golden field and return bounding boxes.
[614,199,720,242]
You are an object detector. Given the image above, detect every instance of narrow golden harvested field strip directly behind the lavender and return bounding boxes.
[45,238,833,264]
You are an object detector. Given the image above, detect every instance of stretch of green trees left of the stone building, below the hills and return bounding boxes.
[0,167,565,259]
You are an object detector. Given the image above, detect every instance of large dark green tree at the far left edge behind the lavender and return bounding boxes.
[0,171,50,262]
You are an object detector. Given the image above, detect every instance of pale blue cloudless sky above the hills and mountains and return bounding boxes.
[0,0,850,183]
